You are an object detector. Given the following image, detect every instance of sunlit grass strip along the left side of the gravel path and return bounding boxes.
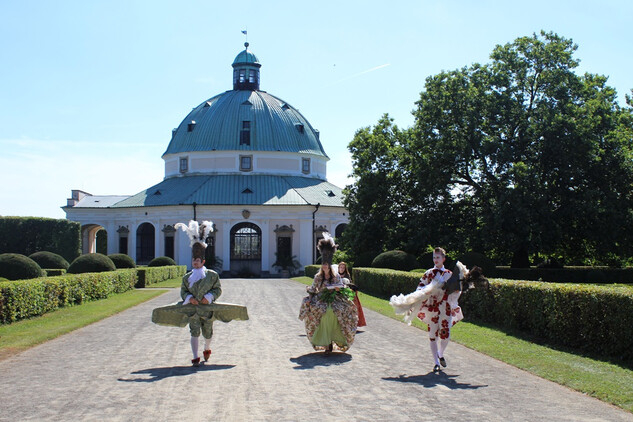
[0,290,165,360]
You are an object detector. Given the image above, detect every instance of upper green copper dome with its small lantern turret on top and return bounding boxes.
[163,43,327,159]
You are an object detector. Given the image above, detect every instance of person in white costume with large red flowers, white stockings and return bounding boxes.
[417,248,464,372]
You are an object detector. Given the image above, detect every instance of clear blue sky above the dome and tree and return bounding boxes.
[0,0,633,218]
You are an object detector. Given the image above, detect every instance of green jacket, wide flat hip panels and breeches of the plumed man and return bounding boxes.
[152,270,248,338]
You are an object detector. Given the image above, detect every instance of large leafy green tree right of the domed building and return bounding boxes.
[345,32,633,267]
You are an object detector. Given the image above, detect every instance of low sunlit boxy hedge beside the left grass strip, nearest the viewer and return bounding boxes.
[0,270,137,324]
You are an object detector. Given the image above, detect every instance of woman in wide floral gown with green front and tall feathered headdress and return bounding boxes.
[299,233,358,354]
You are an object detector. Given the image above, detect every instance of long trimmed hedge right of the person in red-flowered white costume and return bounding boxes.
[460,279,633,361]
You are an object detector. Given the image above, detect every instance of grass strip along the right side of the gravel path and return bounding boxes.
[293,277,633,412]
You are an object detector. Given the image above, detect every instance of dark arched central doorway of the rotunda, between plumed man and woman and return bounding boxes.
[231,223,262,277]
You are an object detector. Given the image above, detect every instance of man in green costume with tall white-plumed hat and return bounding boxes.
[152,221,248,366]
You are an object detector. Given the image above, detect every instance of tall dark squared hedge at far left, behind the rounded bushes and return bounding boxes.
[0,217,81,262]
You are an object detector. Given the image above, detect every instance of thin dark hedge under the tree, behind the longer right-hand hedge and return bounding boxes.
[494,267,633,284]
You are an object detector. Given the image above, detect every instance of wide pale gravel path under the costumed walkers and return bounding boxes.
[0,279,633,422]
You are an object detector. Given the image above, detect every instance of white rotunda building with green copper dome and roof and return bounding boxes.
[63,43,348,276]
